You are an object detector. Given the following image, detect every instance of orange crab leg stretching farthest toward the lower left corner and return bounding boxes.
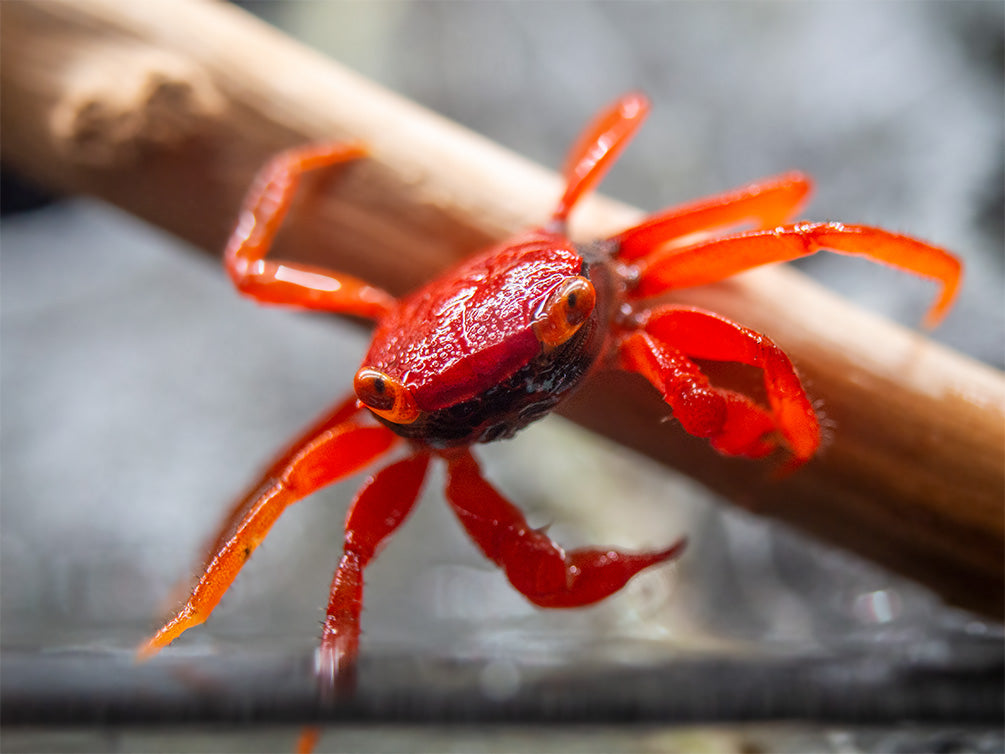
[139,422,397,657]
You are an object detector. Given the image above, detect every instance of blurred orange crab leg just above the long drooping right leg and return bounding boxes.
[611,172,811,261]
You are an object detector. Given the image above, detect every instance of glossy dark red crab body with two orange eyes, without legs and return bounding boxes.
[355,230,614,447]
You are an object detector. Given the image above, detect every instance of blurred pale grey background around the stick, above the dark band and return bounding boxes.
[0,1,1005,751]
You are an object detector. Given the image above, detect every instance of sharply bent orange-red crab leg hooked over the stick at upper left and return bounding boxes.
[223,144,394,318]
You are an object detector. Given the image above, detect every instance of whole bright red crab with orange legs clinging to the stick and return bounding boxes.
[140,93,961,688]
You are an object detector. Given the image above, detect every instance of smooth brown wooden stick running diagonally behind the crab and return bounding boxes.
[0,0,1005,617]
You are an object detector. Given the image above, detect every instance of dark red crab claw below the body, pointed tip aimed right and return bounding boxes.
[446,448,684,607]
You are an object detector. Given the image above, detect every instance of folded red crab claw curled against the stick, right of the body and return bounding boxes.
[618,306,820,467]
